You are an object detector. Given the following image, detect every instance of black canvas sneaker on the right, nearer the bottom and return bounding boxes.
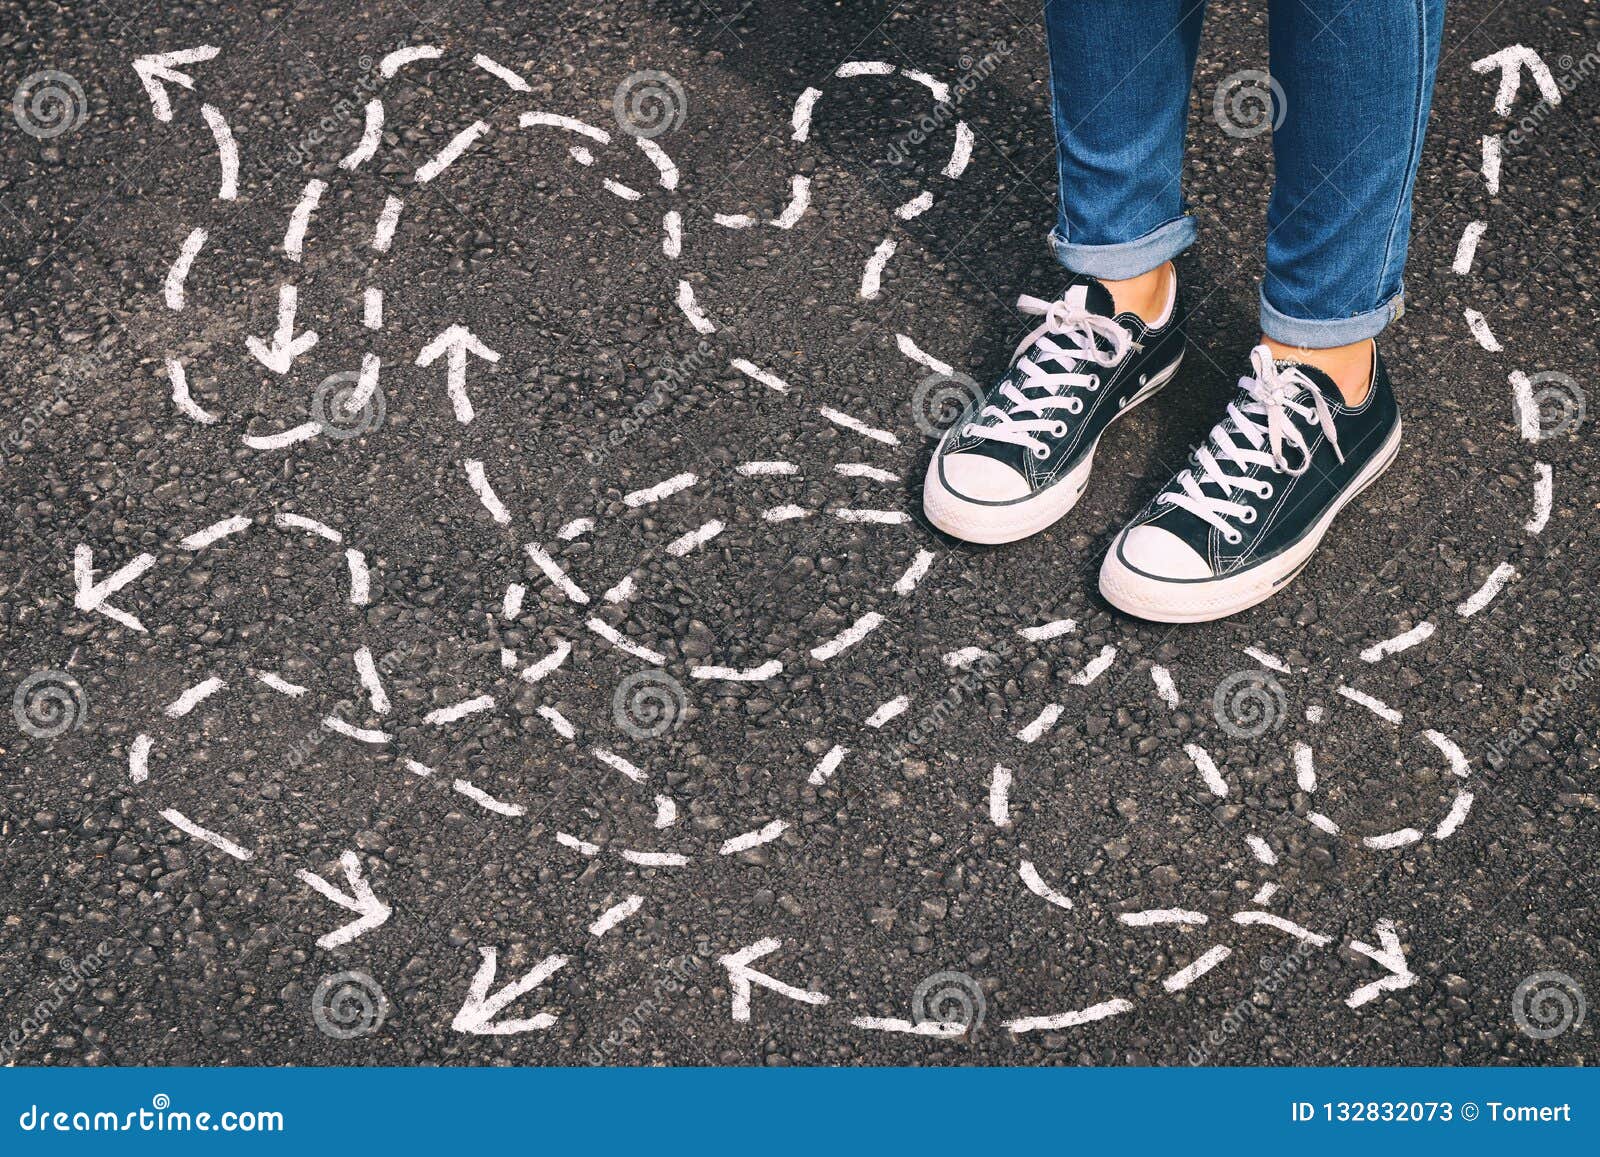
[1101,344,1400,623]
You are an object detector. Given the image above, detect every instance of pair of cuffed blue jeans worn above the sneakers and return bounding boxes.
[1045,0,1445,349]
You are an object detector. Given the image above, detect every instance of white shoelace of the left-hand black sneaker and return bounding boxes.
[962,285,1138,459]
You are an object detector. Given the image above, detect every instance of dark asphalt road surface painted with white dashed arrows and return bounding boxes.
[0,0,1600,1064]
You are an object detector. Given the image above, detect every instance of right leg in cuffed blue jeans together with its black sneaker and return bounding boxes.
[1101,0,1443,623]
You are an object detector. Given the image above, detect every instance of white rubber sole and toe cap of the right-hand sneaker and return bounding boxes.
[1099,419,1400,623]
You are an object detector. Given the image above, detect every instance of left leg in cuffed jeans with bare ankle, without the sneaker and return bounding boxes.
[1045,0,1205,320]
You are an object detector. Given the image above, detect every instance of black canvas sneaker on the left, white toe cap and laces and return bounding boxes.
[922,277,1184,542]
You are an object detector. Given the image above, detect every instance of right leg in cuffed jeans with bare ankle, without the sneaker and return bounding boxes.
[1261,0,1445,403]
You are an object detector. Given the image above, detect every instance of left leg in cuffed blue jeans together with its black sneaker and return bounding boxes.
[923,0,1205,542]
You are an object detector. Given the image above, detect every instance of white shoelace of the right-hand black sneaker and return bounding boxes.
[1157,346,1344,546]
